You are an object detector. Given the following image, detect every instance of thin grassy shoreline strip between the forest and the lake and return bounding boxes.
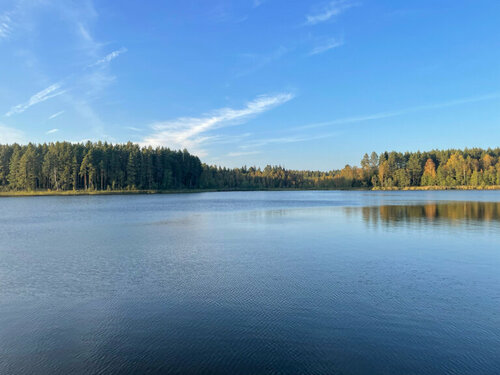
[0,185,500,197]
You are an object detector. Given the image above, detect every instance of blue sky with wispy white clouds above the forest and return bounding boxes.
[0,0,500,170]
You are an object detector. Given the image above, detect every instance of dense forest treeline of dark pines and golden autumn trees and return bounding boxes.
[0,142,500,191]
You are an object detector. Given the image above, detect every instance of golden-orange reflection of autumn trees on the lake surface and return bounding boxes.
[362,202,500,224]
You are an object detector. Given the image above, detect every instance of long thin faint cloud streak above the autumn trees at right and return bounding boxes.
[295,93,500,129]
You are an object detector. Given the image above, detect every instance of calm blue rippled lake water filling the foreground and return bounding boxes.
[0,191,500,375]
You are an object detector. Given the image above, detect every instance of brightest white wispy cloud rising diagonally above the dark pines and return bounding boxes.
[142,93,294,156]
